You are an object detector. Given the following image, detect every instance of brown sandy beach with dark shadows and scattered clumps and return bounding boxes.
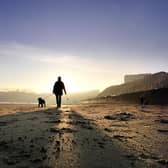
[0,104,168,168]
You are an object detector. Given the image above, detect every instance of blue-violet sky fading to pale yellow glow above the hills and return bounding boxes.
[0,0,168,92]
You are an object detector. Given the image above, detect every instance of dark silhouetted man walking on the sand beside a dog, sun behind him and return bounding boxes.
[53,76,66,108]
